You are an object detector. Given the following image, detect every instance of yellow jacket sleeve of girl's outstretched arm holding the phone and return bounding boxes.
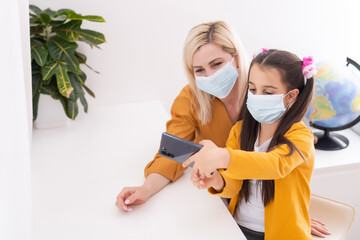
[223,124,314,179]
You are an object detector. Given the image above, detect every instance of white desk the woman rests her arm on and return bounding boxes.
[32,102,245,240]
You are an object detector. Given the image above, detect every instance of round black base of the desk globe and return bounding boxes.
[314,130,349,151]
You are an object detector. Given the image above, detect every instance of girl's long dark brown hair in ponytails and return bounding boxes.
[239,49,314,206]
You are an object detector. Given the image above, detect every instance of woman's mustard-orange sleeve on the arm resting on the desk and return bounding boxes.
[144,86,197,181]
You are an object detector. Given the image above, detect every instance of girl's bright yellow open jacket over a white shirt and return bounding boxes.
[209,121,315,240]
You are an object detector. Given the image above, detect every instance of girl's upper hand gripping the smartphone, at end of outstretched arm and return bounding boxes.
[183,140,230,178]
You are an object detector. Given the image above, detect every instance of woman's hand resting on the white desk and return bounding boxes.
[115,186,150,212]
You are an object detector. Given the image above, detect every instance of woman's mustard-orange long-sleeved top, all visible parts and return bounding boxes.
[145,85,234,181]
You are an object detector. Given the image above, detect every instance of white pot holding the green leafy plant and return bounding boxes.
[34,94,70,129]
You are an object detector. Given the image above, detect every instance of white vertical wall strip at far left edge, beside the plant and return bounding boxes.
[0,0,32,240]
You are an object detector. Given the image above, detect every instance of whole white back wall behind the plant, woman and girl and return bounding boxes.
[30,0,360,111]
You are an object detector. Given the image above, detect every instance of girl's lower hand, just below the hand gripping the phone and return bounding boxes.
[191,169,224,192]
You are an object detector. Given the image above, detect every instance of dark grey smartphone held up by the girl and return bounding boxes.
[159,132,203,167]
